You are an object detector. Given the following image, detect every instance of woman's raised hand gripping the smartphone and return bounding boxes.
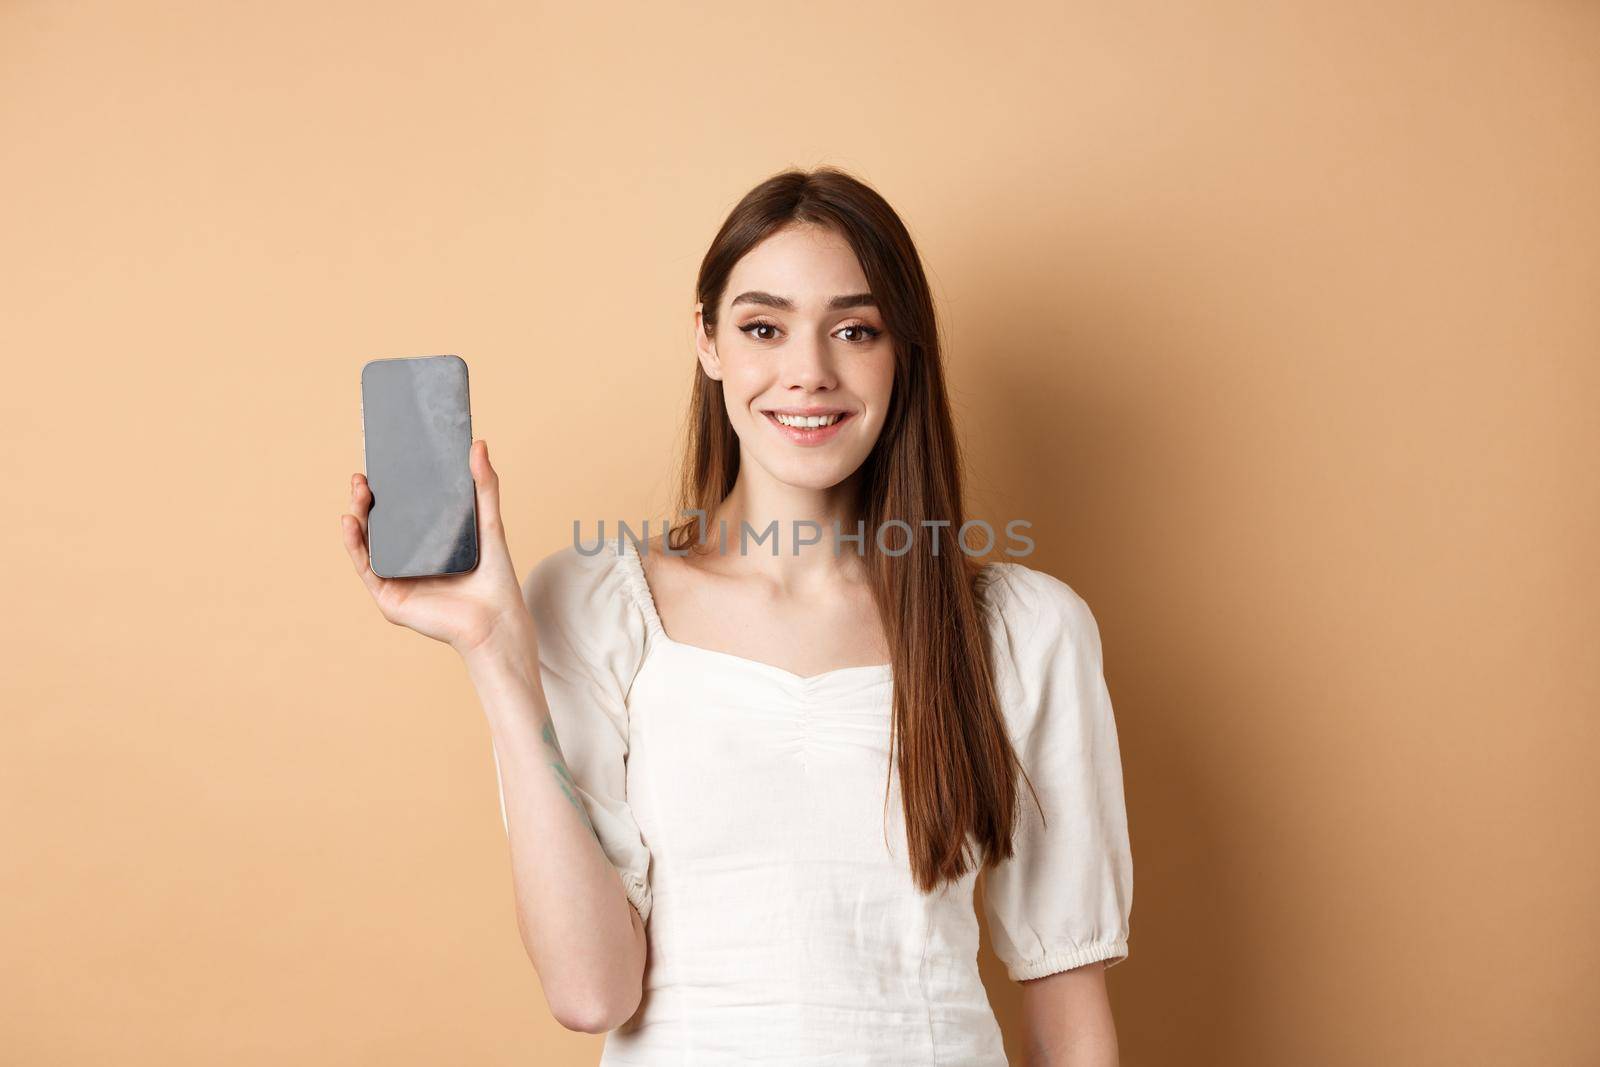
[339,440,534,659]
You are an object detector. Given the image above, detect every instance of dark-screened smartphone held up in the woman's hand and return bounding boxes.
[362,355,478,577]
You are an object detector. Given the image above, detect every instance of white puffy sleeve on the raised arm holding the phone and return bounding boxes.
[494,545,651,921]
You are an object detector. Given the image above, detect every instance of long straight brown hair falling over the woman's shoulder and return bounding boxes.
[667,166,1038,893]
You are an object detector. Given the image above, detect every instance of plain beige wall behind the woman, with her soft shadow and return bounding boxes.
[0,0,1600,1065]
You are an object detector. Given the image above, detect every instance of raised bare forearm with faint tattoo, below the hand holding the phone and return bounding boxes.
[466,624,645,1032]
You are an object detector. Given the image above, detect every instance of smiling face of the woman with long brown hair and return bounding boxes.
[694,224,894,490]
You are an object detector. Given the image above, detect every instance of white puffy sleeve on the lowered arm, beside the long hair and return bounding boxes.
[984,563,1133,982]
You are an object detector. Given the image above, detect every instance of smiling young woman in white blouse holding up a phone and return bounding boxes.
[341,168,1133,1067]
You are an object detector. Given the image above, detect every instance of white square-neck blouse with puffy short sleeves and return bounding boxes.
[496,537,1133,1067]
